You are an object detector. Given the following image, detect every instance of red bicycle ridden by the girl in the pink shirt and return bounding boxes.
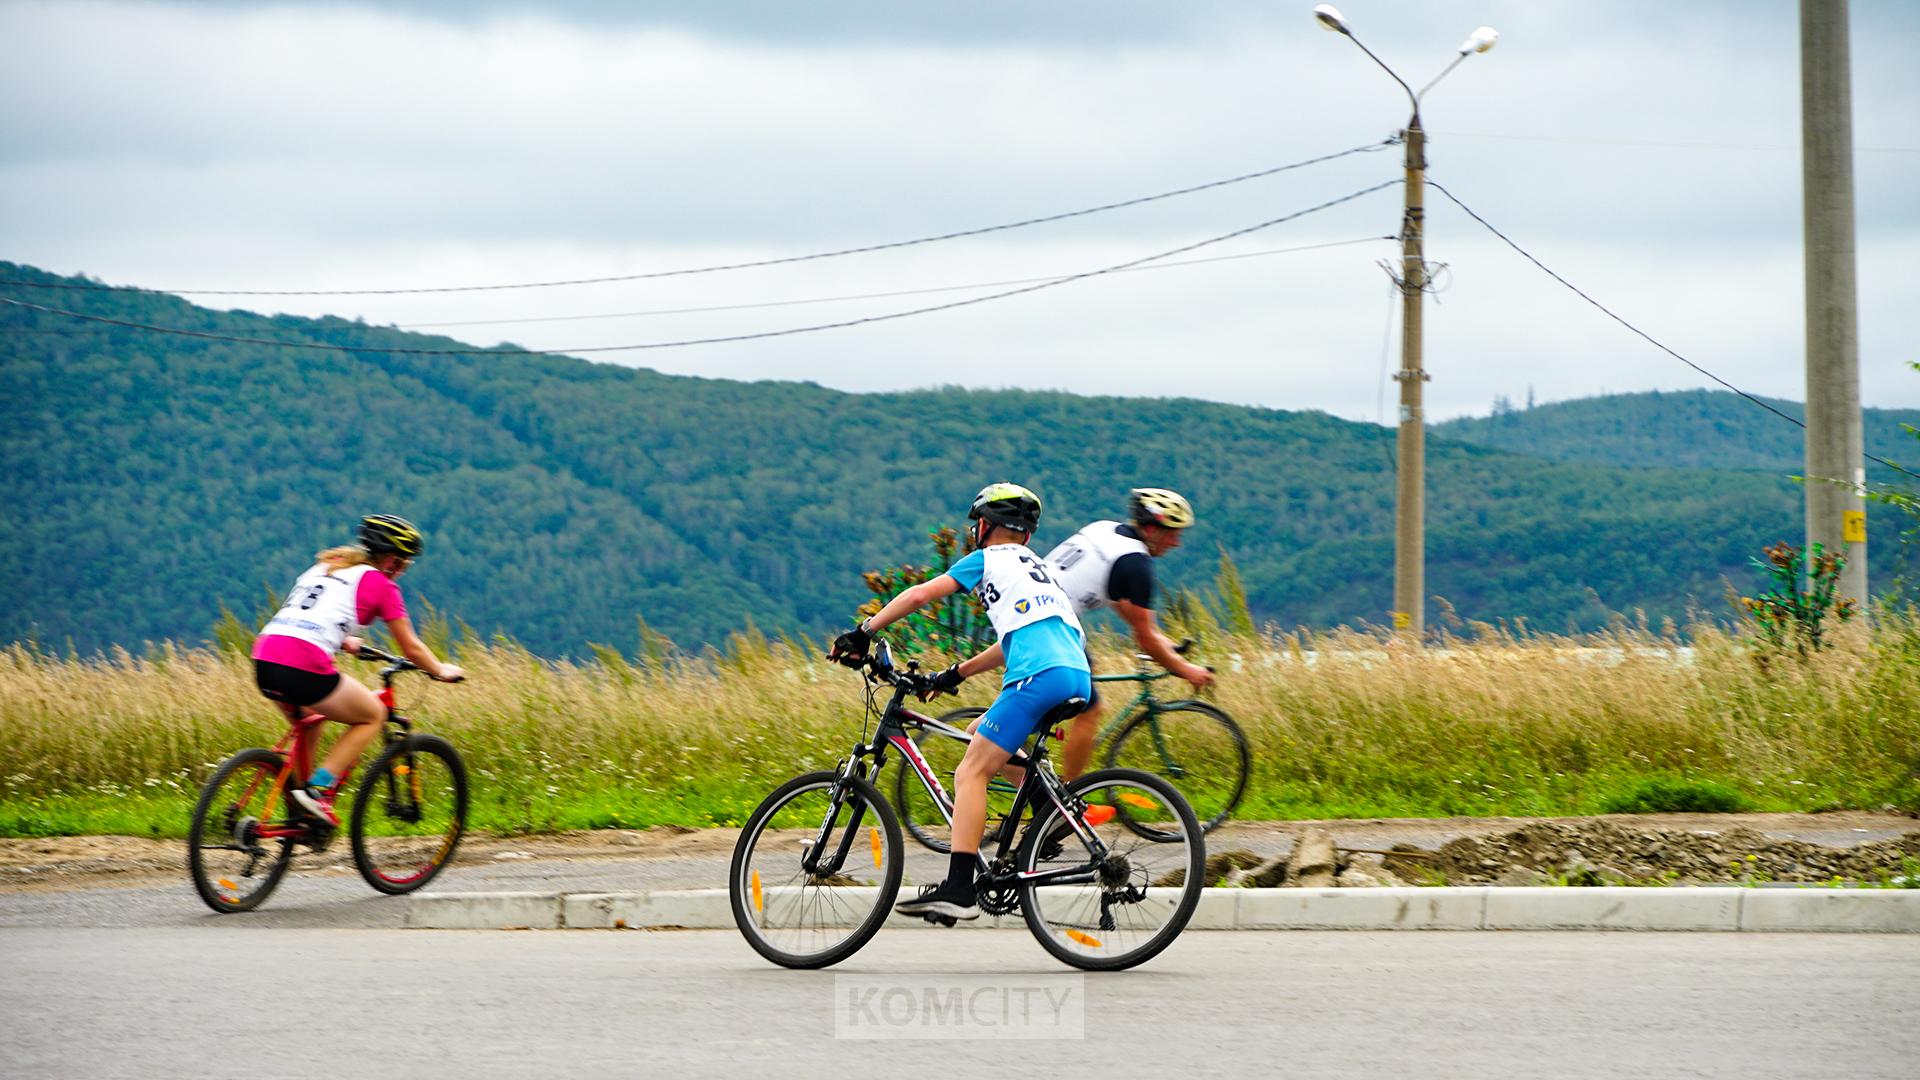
[186,646,467,915]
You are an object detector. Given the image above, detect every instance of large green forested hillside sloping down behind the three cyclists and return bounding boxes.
[0,263,1893,653]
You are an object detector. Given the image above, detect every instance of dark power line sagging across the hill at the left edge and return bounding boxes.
[0,177,1402,356]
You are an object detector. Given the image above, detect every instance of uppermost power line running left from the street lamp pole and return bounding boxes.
[0,136,1400,296]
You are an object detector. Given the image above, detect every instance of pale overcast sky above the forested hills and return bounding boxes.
[0,0,1920,421]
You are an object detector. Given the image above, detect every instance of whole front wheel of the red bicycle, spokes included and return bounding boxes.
[351,734,467,896]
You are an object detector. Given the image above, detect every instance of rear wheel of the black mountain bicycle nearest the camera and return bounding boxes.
[1014,769,1206,970]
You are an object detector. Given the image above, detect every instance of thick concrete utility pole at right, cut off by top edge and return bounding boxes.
[1801,0,1866,605]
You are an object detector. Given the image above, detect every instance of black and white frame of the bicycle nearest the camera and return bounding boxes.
[801,668,1106,888]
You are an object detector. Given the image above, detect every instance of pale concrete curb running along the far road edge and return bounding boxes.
[407,886,1920,934]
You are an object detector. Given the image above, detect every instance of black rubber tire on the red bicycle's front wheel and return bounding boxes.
[348,734,468,896]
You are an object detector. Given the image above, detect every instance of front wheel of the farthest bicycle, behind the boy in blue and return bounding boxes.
[1106,701,1254,832]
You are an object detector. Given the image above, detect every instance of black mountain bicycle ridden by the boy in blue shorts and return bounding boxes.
[728,642,1206,970]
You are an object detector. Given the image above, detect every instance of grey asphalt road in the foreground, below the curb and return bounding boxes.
[0,928,1920,1080]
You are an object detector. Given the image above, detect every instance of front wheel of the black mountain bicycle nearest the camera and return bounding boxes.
[728,773,906,967]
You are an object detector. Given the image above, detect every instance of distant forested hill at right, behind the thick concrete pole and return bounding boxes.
[1432,384,1920,479]
